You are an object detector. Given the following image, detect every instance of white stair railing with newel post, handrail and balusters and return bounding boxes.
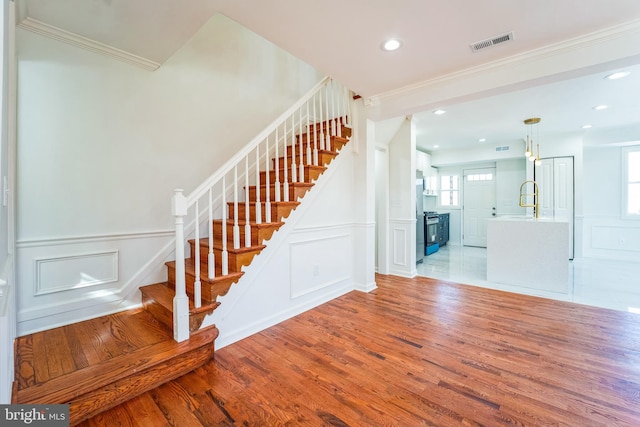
[172,77,351,341]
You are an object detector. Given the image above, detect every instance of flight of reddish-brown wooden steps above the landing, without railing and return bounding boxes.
[140,119,351,333]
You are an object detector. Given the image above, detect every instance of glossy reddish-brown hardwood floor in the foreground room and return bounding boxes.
[81,275,640,427]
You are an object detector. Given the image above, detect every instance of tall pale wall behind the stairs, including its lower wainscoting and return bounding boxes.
[17,15,321,334]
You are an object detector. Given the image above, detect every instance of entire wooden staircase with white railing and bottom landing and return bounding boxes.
[12,79,351,425]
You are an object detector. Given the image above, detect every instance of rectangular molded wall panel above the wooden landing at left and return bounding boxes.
[33,250,118,296]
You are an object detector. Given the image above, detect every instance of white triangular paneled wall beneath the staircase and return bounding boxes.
[211,124,375,348]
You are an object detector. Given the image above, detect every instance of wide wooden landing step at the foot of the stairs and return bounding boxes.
[12,309,218,425]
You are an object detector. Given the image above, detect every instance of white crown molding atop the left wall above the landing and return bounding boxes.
[18,17,160,71]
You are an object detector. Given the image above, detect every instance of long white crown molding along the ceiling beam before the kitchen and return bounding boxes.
[365,19,640,110]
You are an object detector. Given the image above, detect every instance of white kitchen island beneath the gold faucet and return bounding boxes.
[487,216,569,294]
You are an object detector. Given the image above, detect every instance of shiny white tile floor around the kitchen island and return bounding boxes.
[417,245,640,314]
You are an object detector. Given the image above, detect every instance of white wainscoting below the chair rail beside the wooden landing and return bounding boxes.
[16,231,174,335]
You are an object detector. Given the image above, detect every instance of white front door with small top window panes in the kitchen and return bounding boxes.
[462,168,496,248]
